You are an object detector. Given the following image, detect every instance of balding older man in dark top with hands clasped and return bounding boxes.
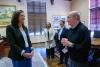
[61,11,91,67]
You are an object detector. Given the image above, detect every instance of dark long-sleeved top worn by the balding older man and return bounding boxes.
[68,22,91,62]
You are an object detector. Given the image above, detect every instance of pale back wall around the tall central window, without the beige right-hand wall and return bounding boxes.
[0,0,70,43]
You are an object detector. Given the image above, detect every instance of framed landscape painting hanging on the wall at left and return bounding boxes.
[0,5,16,27]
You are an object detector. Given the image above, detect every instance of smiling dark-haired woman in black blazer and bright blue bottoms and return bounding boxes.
[6,10,33,67]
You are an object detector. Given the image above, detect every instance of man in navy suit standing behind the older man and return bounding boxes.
[54,20,68,65]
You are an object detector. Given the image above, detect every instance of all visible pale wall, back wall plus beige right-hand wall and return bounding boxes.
[0,0,89,43]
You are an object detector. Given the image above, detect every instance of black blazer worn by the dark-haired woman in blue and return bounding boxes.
[6,25,32,60]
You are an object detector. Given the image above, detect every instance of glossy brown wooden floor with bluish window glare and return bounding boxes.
[1,43,64,67]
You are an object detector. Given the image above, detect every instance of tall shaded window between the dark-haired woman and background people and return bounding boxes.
[27,0,46,35]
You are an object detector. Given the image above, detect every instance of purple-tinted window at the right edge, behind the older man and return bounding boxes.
[90,0,100,31]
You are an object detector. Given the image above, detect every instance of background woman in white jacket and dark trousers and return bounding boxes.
[44,23,55,59]
